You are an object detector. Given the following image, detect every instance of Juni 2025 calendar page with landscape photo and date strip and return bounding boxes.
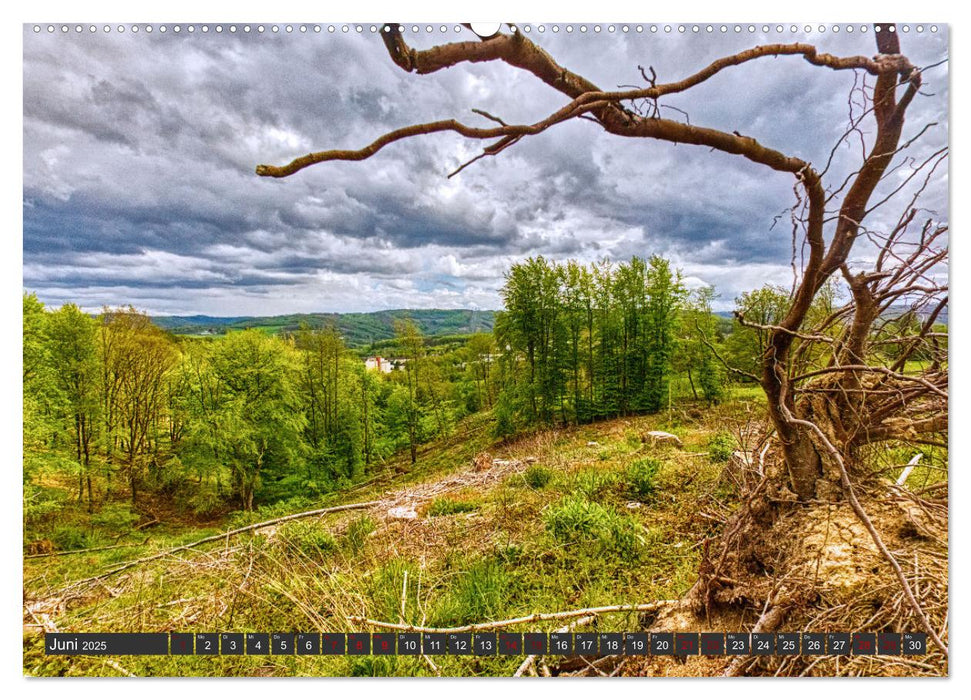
[22,20,950,678]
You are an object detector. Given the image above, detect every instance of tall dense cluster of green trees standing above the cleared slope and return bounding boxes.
[495,256,685,435]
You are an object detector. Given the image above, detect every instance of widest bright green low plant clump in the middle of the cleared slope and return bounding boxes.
[543,494,644,559]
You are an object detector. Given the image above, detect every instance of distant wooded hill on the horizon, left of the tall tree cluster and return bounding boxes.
[158,309,495,347]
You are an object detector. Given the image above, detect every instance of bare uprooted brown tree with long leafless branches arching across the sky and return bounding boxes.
[256,24,948,649]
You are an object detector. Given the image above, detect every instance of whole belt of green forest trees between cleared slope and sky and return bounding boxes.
[23,257,786,532]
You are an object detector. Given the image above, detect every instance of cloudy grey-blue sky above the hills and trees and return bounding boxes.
[23,25,948,316]
